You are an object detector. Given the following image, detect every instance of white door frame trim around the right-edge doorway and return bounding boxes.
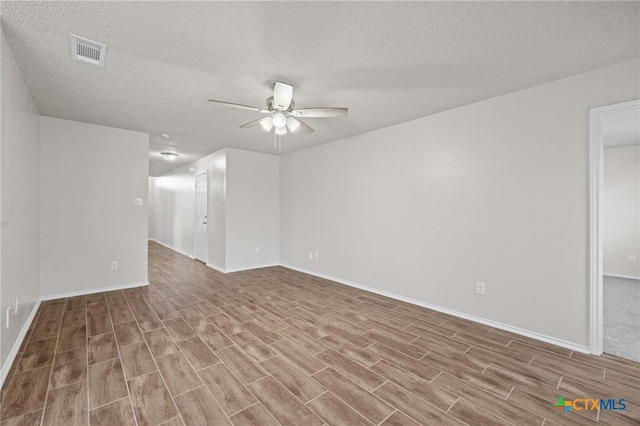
[589,100,640,355]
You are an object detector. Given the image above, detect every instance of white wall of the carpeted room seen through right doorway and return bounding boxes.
[603,145,640,279]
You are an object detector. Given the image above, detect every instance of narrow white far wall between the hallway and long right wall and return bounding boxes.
[225,149,280,271]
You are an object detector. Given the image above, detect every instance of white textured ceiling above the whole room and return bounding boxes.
[1,1,640,175]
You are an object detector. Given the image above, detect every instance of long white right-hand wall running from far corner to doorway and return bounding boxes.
[280,61,639,346]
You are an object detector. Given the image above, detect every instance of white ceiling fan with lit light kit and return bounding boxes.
[209,81,349,149]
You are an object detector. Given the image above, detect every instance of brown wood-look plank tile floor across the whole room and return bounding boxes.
[0,243,640,426]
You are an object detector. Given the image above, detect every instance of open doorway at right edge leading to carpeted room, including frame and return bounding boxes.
[589,101,640,361]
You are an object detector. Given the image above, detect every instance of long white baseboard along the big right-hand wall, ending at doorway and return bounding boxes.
[281,265,591,354]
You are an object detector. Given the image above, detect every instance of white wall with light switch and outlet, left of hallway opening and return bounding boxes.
[40,117,149,298]
